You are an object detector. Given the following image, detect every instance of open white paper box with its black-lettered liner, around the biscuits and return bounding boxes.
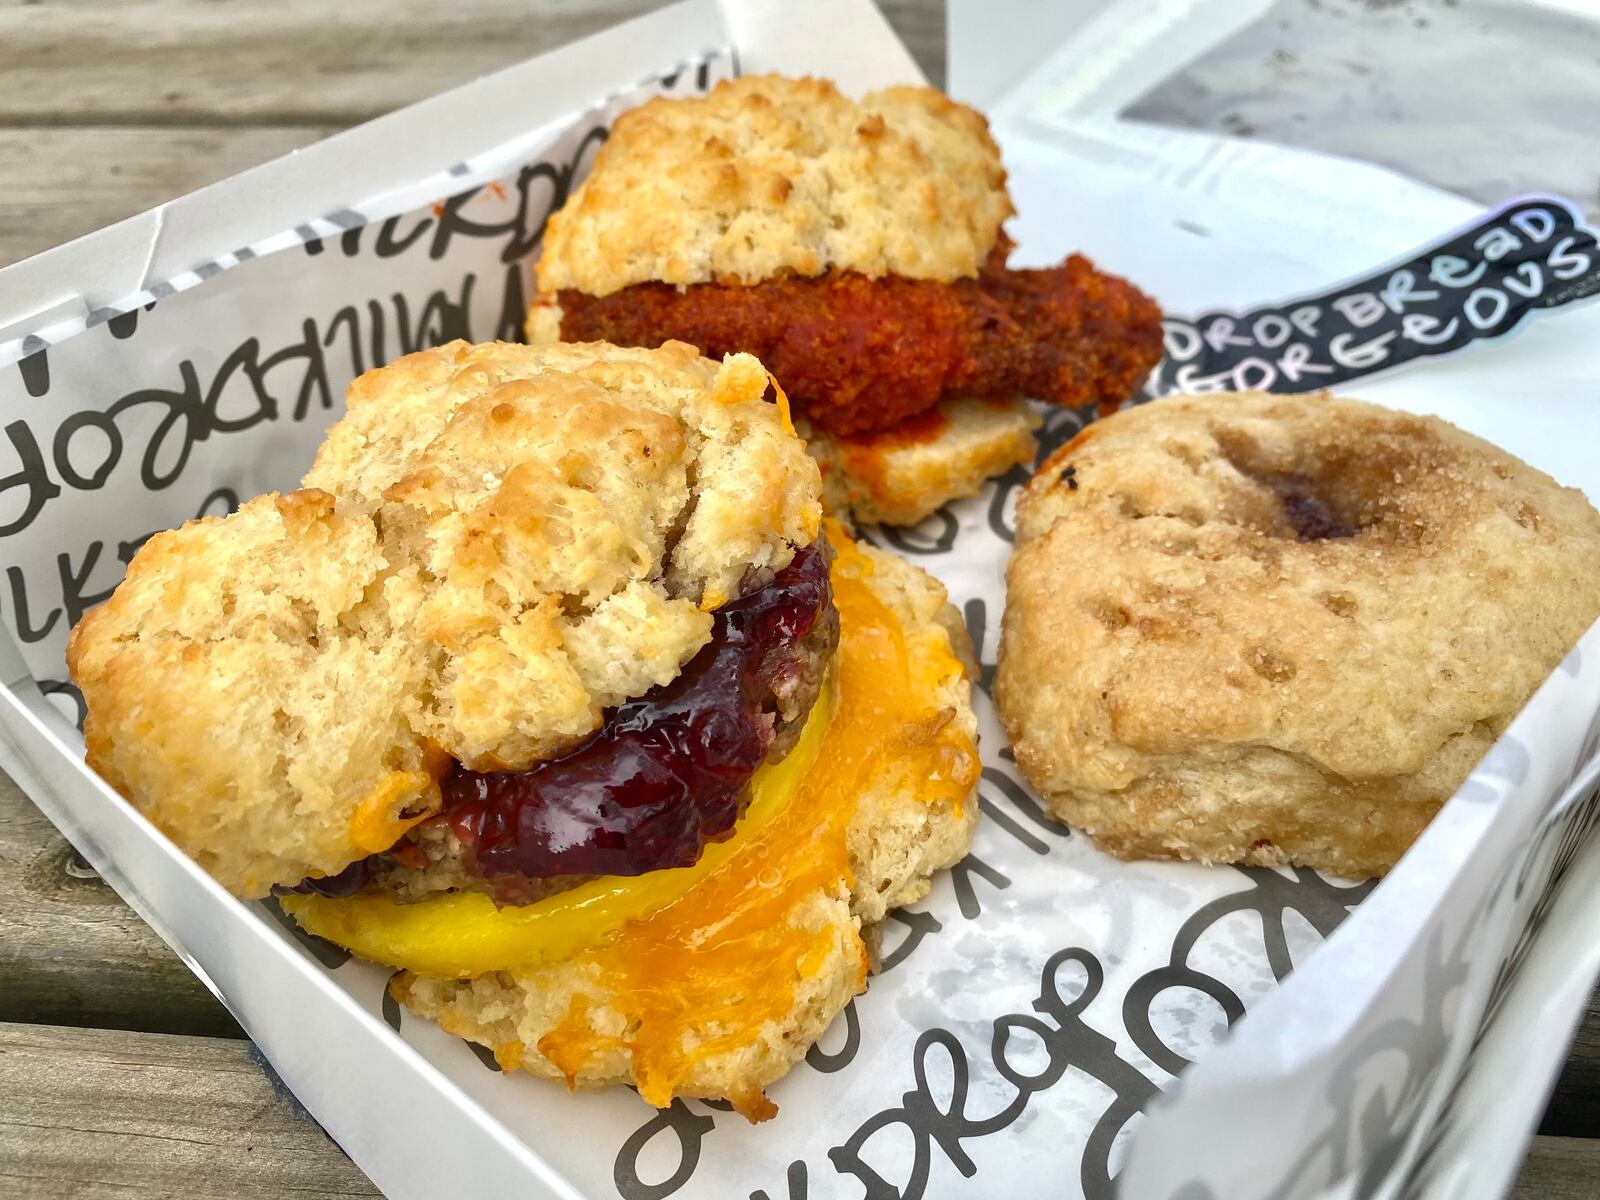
[9,0,1600,1200]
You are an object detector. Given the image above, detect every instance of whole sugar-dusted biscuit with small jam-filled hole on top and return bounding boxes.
[995,392,1600,877]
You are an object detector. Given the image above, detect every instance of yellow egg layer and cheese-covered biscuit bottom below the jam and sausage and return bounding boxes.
[282,531,979,1120]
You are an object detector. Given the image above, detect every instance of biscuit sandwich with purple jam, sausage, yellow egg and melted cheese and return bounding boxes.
[69,342,979,1120]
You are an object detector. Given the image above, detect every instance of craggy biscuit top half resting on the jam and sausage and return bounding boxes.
[67,342,821,894]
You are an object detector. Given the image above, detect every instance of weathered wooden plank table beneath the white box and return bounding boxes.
[0,0,1600,1200]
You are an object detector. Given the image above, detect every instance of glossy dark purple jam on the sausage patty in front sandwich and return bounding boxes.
[443,544,832,878]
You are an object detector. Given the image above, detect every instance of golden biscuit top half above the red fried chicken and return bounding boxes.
[538,75,1013,296]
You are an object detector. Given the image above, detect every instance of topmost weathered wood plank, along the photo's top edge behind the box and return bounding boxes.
[0,0,944,125]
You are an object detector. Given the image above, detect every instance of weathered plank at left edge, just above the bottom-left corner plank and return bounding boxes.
[0,774,242,1036]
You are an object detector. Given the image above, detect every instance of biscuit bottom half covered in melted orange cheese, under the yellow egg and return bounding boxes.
[300,544,978,1118]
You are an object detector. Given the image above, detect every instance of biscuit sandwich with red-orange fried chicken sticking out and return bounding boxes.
[526,75,1162,525]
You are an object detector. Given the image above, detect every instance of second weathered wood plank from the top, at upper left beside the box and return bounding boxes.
[0,125,338,267]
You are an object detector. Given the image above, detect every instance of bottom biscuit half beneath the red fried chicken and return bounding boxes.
[795,397,1042,525]
